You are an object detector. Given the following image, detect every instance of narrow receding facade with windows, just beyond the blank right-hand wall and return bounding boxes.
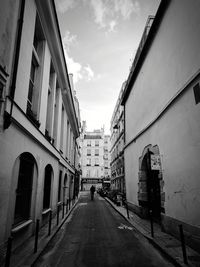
[110,83,126,194]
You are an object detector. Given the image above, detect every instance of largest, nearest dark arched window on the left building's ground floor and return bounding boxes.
[14,153,35,225]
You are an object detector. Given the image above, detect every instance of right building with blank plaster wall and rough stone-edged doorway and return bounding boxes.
[122,0,200,253]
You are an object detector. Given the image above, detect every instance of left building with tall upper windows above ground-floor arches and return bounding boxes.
[0,0,80,256]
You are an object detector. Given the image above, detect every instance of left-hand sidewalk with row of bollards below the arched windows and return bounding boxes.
[2,199,78,267]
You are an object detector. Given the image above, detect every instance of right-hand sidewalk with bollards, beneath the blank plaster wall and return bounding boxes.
[105,198,200,267]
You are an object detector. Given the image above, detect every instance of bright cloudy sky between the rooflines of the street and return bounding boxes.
[55,0,160,134]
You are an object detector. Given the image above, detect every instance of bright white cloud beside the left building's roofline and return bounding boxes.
[62,31,95,83]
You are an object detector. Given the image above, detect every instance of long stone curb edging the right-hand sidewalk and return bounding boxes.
[104,197,183,267]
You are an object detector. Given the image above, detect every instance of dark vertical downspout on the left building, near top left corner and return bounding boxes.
[4,0,25,129]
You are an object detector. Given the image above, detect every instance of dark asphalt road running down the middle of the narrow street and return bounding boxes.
[33,192,173,267]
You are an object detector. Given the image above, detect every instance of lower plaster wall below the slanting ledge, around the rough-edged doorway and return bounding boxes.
[125,84,200,226]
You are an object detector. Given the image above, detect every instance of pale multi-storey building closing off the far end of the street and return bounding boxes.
[81,121,110,190]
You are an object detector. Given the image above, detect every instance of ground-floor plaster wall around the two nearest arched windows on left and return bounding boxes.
[0,124,67,243]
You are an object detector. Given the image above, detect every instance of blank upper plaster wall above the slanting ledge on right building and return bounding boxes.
[126,0,200,146]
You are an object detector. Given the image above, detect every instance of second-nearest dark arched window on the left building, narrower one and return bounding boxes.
[43,165,52,210]
